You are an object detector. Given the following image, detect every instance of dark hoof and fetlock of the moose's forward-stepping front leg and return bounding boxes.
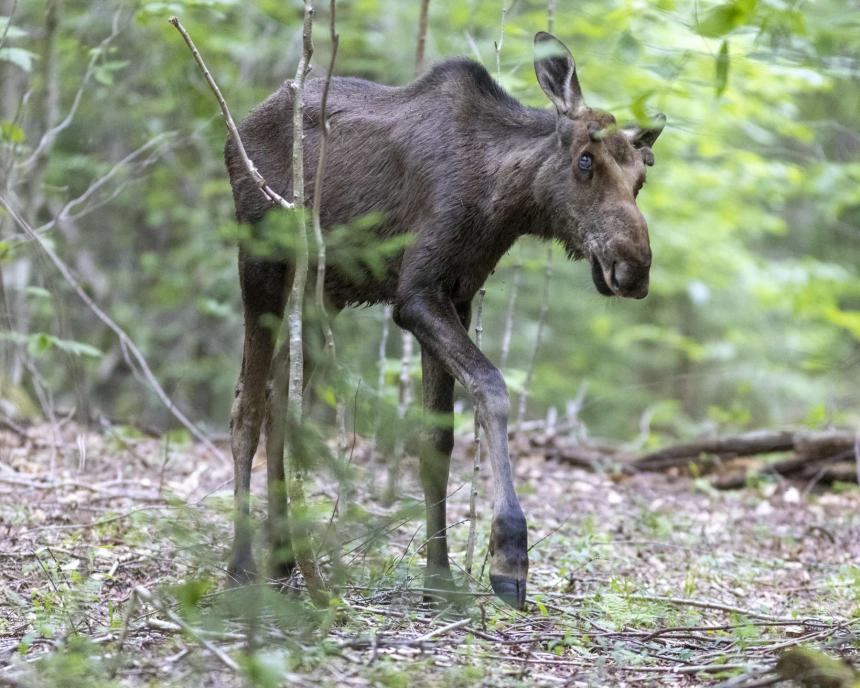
[490,508,529,609]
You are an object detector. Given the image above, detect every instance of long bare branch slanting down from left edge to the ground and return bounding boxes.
[0,195,226,461]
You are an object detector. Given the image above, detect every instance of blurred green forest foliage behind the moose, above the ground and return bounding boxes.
[0,0,860,444]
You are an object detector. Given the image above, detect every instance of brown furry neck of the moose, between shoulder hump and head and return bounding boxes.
[491,108,579,254]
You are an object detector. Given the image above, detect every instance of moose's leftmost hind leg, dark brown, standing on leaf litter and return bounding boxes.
[227,259,286,584]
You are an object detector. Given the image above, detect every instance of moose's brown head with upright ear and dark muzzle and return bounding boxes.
[534,31,666,299]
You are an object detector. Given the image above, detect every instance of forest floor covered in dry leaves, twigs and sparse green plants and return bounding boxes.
[0,424,860,688]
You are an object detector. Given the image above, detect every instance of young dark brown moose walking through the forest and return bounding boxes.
[225,32,665,608]
